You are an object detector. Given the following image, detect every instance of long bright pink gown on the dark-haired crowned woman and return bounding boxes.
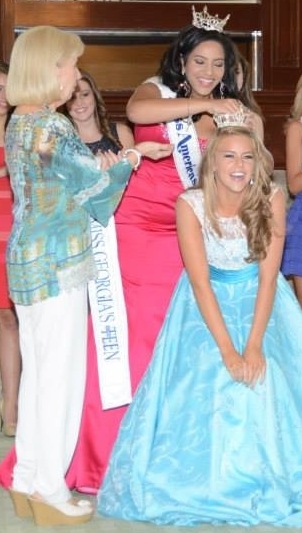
[0,125,203,493]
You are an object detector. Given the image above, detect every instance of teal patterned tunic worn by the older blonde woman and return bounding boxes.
[5,108,132,305]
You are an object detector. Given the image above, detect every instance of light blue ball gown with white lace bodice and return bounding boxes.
[98,186,302,527]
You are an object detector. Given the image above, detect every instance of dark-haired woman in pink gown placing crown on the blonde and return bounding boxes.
[67,19,250,493]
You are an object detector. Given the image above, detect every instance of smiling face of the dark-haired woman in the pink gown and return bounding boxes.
[184,41,225,98]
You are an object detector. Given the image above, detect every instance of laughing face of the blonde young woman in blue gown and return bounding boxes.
[214,134,255,195]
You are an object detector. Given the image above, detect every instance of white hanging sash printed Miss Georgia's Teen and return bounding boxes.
[88,217,132,409]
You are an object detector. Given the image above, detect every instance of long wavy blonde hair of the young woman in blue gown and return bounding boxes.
[197,126,274,262]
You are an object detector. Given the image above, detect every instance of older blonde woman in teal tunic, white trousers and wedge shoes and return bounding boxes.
[1,26,172,525]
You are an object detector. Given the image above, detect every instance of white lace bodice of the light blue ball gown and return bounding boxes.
[181,189,249,270]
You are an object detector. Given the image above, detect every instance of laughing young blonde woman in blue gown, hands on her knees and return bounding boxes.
[98,122,302,527]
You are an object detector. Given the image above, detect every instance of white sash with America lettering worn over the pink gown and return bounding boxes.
[145,76,201,189]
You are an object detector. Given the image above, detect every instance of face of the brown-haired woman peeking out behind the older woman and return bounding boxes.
[66,80,96,122]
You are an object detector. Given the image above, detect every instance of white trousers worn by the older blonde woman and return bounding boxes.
[13,287,87,503]
